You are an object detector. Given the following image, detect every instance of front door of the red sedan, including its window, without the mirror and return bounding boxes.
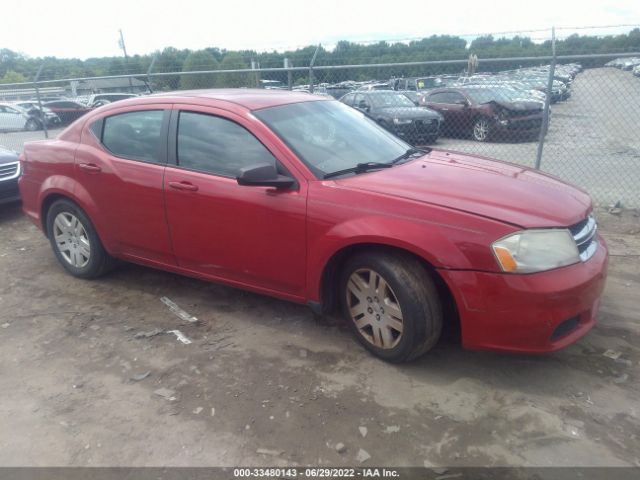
[164,105,307,299]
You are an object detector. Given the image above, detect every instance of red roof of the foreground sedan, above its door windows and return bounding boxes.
[146,88,330,110]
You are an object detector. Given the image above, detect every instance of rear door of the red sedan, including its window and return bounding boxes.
[75,105,176,265]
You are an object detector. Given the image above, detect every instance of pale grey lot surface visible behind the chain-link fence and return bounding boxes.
[0,68,640,208]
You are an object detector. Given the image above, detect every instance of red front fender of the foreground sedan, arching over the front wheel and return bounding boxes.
[307,181,514,301]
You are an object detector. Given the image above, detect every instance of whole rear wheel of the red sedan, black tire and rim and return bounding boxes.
[47,199,115,279]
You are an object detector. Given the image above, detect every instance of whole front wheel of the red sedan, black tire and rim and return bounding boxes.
[339,250,442,363]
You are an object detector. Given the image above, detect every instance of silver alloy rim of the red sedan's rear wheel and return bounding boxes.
[53,212,91,268]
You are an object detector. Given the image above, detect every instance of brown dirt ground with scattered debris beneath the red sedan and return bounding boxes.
[0,202,640,467]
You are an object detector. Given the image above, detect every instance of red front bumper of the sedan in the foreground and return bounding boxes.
[440,238,608,353]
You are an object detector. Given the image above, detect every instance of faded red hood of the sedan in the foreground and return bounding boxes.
[337,150,591,228]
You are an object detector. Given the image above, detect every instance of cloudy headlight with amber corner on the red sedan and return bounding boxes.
[491,229,580,273]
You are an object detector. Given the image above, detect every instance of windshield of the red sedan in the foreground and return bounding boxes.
[254,99,413,178]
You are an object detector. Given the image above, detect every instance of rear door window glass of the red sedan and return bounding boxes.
[102,110,164,163]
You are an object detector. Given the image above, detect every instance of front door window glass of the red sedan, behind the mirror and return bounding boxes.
[178,112,277,177]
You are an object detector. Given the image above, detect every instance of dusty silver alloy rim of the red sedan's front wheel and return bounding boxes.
[346,268,404,349]
